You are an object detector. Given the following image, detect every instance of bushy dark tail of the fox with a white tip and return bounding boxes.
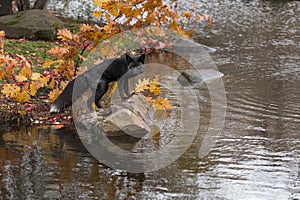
[50,79,75,112]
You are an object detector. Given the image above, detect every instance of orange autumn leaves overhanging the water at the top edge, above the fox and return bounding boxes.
[94,0,207,36]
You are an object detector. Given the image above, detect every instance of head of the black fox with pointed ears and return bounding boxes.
[126,54,146,77]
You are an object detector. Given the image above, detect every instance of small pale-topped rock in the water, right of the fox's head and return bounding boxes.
[177,69,224,86]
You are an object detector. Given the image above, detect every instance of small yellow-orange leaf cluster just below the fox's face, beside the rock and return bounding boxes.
[135,75,172,110]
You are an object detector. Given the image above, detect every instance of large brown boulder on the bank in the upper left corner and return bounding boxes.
[0,10,65,41]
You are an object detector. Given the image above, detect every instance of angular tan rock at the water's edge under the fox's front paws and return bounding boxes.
[78,94,152,138]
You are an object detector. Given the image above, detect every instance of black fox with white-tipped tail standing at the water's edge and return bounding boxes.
[50,54,145,112]
